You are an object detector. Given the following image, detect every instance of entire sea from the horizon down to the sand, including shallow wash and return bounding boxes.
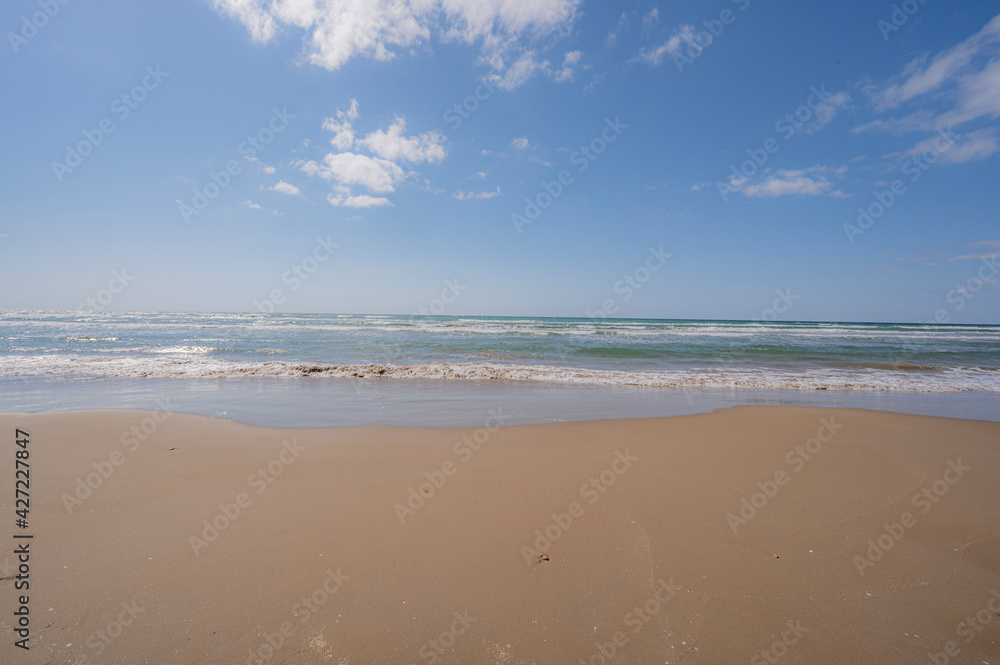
[0,311,1000,425]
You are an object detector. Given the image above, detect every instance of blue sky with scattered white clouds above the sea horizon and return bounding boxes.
[0,0,1000,324]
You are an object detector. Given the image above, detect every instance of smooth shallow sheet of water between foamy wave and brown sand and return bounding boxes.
[0,378,1000,427]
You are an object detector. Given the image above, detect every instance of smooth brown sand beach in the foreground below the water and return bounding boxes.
[0,407,1000,665]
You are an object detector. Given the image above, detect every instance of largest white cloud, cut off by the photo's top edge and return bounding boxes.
[213,0,581,87]
